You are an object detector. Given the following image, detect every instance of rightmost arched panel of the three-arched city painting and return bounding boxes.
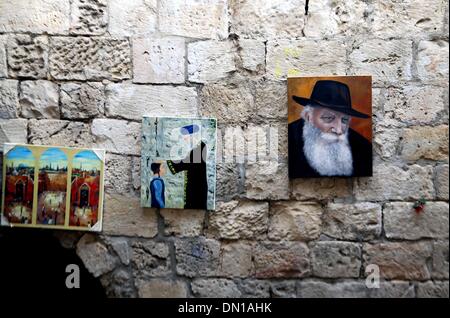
[69,150,102,228]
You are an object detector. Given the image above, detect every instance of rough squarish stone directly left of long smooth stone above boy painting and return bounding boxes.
[60,83,105,119]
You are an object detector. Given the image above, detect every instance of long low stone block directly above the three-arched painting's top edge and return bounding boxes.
[28,119,93,148]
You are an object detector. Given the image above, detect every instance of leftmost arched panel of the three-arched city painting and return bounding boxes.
[4,146,35,224]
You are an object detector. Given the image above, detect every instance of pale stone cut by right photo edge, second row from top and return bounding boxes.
[417,40,449,82]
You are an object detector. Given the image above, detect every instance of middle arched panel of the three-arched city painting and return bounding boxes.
[37,148,68,225]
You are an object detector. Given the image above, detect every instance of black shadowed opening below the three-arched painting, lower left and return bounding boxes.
[0,228,106,302]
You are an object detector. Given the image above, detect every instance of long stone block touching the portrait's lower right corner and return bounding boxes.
[354,164,434,201]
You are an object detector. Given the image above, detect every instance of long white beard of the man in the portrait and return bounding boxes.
[303,121,353,176]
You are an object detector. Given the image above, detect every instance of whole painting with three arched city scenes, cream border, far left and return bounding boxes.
[0,144,105,232]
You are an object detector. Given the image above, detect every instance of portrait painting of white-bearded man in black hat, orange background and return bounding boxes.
[288,76,372,179]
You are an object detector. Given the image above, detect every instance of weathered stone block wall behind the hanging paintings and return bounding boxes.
[0,0,449,297]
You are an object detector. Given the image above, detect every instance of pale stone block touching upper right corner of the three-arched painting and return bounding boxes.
[92,119,141,155]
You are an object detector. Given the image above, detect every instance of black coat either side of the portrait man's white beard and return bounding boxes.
[288,119,372,179]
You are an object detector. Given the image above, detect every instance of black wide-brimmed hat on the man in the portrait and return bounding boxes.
[293,80,369,118]
